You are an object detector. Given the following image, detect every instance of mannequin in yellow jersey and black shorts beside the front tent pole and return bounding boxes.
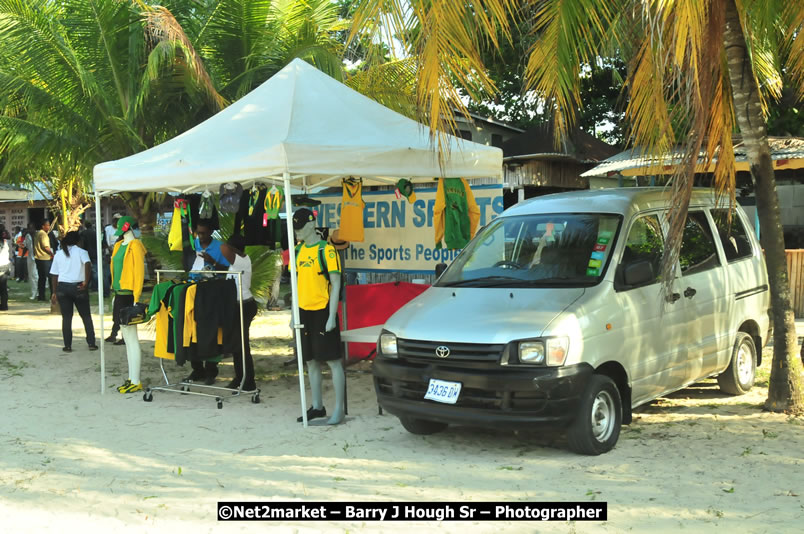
[291,208,346,425]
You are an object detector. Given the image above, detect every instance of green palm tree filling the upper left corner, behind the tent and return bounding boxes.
[0,0,222,232]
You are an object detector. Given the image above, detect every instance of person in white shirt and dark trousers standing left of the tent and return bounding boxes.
[50,231,98,352]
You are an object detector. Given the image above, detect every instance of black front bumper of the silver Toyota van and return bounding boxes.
[373,357,594,428]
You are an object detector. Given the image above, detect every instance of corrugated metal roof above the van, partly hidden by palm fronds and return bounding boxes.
[581,137,804,177]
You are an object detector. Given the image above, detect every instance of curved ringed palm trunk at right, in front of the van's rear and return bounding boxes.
[723,0,804,412]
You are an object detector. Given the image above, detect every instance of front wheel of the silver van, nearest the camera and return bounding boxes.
[567,375,623,456]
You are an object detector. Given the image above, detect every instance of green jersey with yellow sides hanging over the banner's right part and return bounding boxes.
[433,178,480,249]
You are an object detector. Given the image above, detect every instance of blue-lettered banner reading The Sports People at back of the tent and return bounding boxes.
[310,184,503,274]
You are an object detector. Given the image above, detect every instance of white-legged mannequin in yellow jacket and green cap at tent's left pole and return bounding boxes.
[109,216,145,394]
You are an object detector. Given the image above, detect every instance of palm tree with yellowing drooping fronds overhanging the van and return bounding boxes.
[353,0,804,411]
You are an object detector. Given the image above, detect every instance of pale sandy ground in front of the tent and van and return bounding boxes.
[0,282,804,534]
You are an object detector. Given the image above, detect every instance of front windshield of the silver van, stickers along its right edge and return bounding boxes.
[436,213,622,287]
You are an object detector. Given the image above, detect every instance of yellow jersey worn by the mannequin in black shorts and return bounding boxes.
[296,241,341,311]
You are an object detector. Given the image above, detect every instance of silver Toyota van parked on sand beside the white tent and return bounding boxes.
[374,188,770,454]
